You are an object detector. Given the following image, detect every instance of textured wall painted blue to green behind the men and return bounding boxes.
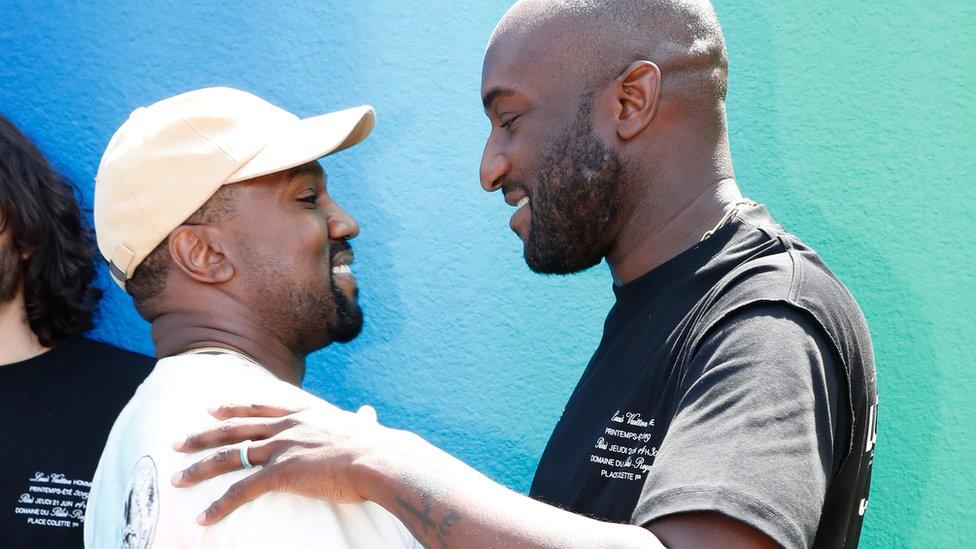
[0,0,976,547]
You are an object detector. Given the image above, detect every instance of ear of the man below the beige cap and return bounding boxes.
[169,225,234,284]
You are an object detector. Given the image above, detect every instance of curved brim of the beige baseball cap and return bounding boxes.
[225,105,376,183]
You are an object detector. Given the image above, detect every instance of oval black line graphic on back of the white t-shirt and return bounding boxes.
[122,456,159,549]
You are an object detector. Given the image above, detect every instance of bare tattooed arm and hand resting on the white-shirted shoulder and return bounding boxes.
[174,404,775,548]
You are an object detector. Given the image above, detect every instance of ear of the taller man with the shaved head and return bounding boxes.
[614,61,661,141]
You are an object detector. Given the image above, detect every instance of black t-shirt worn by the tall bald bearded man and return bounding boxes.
[530,206,877,547]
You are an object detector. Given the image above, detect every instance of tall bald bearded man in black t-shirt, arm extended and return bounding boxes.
[168,0,877,547]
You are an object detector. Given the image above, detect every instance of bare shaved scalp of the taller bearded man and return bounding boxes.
[488,0,728,112]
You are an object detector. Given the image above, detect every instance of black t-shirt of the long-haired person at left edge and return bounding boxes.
[0,336,155,549]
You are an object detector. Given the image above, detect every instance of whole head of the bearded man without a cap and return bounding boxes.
[479,0,732,274]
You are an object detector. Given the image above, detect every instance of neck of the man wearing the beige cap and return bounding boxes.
[152,309,305,386]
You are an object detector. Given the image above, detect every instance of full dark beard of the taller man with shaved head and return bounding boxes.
[513,97,623,274]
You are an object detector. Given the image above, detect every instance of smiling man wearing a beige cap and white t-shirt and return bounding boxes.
[85,88,416,548]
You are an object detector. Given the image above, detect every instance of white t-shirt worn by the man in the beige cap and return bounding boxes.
[85,353,420,549]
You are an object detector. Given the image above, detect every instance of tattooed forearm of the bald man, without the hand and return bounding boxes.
[359,430,662,549]
